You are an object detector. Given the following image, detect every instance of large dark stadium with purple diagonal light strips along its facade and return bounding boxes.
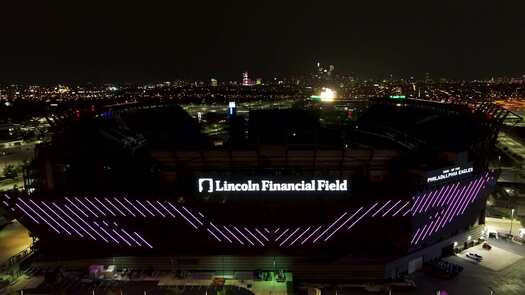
[1,98,505,282]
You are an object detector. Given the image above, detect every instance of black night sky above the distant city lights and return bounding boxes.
[0,0,525,83]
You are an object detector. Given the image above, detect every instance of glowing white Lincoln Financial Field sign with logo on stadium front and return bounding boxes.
[197,178,349,193]
